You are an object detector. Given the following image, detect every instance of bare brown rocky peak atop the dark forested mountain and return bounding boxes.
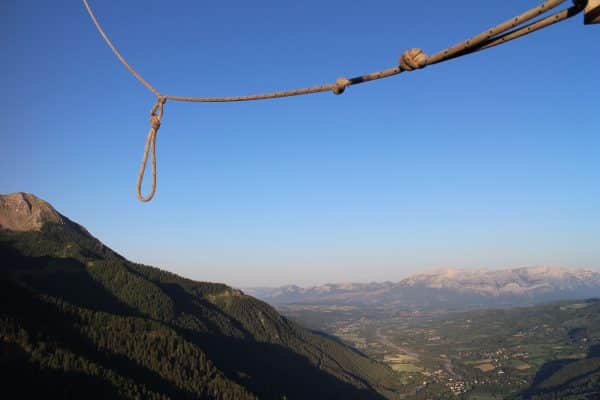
[0,192,65,231]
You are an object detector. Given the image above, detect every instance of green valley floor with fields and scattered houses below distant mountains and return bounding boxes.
[280,300,600,400]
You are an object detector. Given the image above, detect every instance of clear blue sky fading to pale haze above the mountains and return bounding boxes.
[0,0,600,286]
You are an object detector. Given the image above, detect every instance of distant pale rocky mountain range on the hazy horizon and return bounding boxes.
[246,267,600,308]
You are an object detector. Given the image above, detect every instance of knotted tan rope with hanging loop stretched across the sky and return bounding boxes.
[83,0,587,202]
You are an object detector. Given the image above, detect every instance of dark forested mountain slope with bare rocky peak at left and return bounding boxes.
[0,193,401,400]
